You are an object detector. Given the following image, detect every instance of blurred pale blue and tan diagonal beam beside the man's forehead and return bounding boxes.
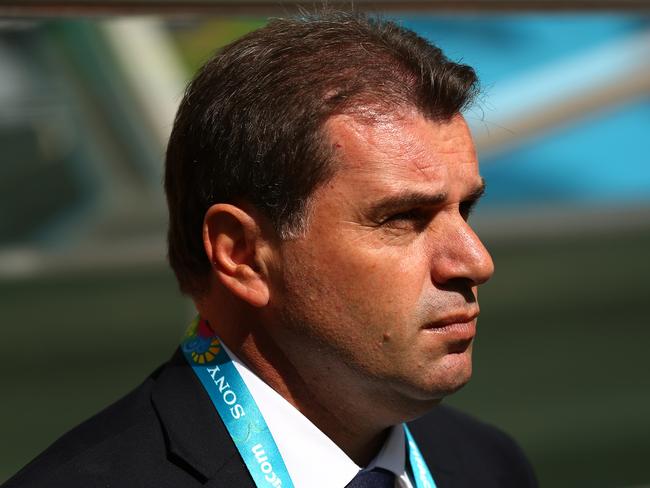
[468,31,650,153]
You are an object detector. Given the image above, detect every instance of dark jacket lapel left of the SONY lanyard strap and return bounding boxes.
[151,349,255,488]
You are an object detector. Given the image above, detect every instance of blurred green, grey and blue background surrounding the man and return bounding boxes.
[0,1,650,487]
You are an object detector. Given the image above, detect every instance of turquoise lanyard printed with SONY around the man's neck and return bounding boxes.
[181,317,436,488]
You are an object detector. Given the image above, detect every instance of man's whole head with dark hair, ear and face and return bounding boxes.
[165,14,493,425]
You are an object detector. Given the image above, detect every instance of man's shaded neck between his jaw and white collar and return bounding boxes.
[197,294,404,466]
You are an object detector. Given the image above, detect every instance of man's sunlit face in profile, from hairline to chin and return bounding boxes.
[272,114,493,416]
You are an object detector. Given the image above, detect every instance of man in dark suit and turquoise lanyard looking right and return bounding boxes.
[2,14,535,488]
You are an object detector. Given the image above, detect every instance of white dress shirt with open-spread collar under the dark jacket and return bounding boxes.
[222,343,413,488]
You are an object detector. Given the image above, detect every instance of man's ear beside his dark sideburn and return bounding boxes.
[203,203,270,307]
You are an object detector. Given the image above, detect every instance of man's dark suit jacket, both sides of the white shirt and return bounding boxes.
[4,351,536,488]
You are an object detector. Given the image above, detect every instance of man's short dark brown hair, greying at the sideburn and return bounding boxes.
[165,12,478,295]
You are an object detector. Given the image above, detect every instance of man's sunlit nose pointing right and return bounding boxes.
[432,217,494,286]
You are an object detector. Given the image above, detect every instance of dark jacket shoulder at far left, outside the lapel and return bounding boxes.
[3,373,196,488]
